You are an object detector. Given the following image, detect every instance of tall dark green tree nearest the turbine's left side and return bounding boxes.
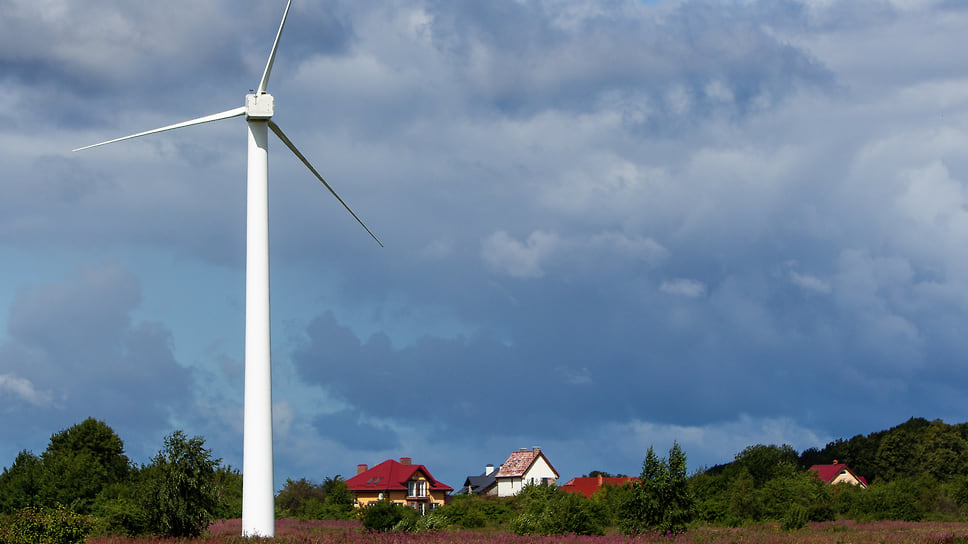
[142,431,220,537]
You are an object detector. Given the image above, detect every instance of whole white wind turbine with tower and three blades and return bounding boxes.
[74,0,383,537]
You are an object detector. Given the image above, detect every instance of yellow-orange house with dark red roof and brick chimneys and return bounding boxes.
[346,457,454,514]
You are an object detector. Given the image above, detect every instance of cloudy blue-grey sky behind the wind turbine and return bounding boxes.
[0,0,968,489]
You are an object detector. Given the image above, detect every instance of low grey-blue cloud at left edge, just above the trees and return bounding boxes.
[0,265,191,462]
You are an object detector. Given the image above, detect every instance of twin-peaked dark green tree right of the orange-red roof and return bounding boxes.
[619,443,696,534]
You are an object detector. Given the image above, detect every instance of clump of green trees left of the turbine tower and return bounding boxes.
[0,418,236,536]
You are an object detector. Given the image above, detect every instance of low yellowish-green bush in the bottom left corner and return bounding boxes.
[0,507,94,544]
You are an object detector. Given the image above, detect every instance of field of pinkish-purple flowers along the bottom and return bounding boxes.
[87,520,968,544]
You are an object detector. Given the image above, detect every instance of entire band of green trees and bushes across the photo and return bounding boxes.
[0,418,968,542]
